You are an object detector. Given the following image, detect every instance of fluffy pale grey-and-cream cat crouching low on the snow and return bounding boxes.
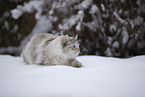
[21,33,82,67]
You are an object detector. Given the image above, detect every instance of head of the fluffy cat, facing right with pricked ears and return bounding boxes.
[62,35,80,57]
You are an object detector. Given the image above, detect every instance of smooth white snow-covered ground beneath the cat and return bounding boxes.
[0,55,145,97]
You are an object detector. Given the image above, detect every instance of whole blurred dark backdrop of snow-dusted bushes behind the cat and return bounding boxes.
[0,0,145,58]
